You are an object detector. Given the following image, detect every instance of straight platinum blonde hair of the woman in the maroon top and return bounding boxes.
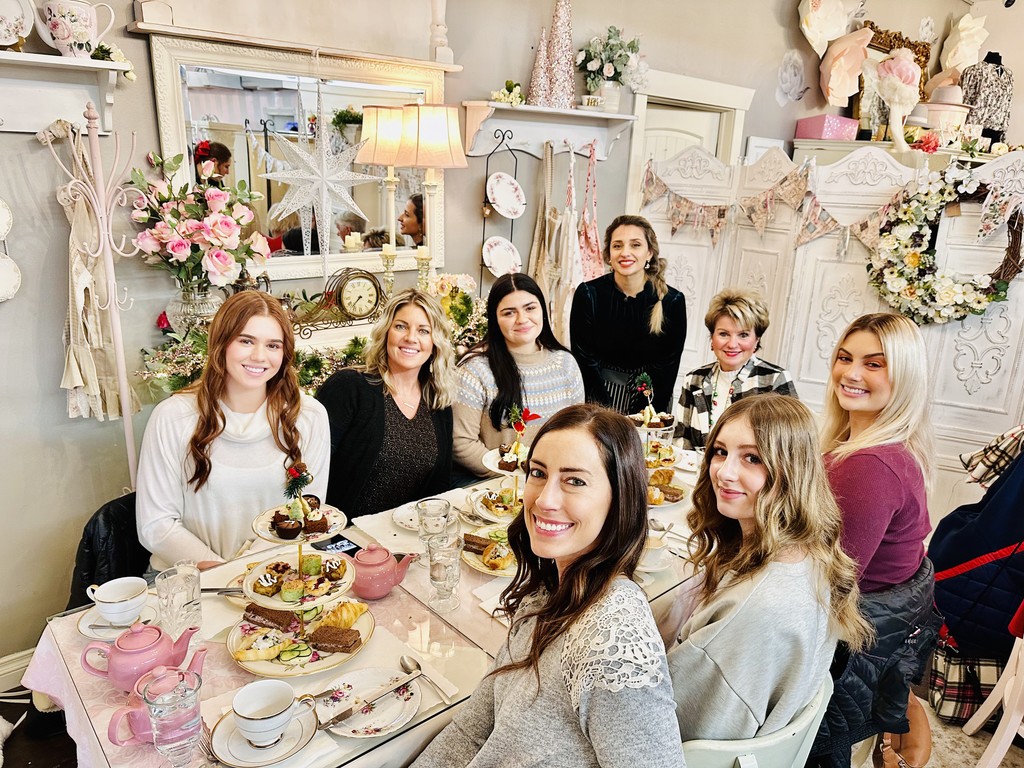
[821,312,935,487]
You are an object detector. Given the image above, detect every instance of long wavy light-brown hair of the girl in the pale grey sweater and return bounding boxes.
[686,394,872,650]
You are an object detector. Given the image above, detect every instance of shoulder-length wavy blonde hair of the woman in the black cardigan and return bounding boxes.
[364,288,456,411]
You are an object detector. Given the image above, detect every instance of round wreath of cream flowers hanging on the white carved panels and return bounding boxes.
[867,165,1024,326]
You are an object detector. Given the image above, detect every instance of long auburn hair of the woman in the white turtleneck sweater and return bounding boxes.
[181,291,302,490]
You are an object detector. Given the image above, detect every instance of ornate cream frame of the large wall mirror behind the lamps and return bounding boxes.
[150,35,444,282]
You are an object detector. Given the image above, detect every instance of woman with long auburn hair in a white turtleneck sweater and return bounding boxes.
[136,291,331,570]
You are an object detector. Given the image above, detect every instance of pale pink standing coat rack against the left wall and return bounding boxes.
[47,101,138,488]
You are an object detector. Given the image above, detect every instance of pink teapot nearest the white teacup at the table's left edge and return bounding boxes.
[82,624,199,691]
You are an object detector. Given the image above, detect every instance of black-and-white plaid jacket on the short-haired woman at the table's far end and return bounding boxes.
[676,355,797,450]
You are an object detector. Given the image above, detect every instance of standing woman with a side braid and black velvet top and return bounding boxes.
[569,215,686,414]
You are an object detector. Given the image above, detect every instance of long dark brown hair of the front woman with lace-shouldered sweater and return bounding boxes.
[492,403,647,674]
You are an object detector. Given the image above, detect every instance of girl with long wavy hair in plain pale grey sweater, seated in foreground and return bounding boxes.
[662,394,870,741]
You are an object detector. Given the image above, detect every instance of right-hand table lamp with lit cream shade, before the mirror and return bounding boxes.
[394,104,468,290]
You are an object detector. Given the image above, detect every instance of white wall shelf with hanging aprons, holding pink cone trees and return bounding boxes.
[462,101,636,160]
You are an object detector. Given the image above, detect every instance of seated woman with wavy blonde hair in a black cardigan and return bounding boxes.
[316,290,455,519]
